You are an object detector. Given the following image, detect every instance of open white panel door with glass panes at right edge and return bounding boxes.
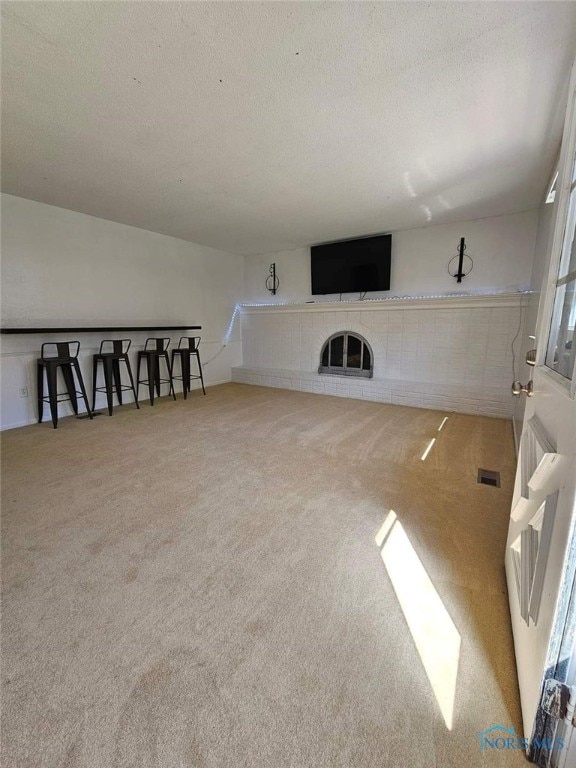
[505,61,576,766]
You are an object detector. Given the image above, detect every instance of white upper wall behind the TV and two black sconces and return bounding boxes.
[244,209,538,303]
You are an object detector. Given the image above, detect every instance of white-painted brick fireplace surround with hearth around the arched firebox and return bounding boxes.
[232,293,527,417]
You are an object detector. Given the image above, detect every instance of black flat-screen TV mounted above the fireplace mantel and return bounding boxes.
[310,235,392,296]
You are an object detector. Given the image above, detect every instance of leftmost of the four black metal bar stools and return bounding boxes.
[36,341,92,429]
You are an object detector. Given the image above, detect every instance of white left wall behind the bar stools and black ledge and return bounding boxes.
[0,195,243,428]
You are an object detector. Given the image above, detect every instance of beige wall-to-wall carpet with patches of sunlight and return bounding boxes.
[2,384,524,768]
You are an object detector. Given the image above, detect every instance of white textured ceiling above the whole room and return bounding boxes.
[1,2,576,253]
